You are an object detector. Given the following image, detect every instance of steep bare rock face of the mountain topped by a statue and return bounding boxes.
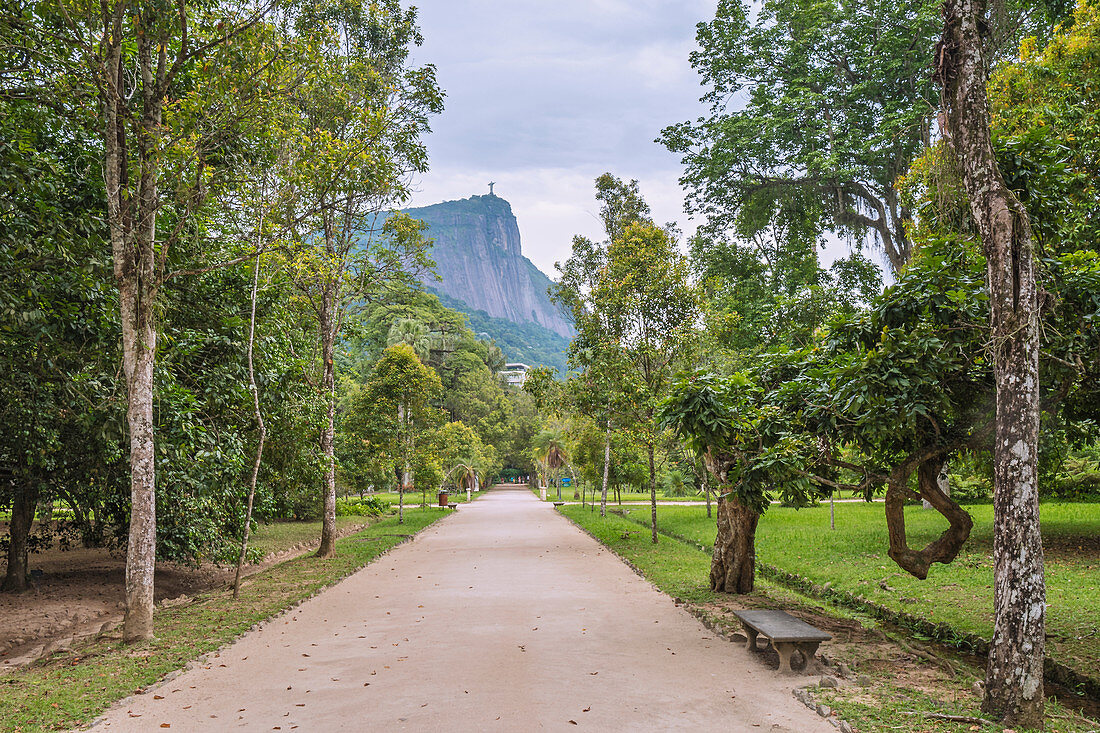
[407,194,573,338]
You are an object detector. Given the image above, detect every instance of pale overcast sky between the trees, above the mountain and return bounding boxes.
[411,0,716,277]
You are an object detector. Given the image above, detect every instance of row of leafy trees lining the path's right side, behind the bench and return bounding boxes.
[528,0,1100,726]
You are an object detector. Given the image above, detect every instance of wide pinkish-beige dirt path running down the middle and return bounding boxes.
[94,485,836,733]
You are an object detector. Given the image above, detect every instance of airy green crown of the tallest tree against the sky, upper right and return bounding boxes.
[660,0,938,273]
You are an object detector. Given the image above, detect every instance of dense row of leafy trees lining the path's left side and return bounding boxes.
[0,0,455,641]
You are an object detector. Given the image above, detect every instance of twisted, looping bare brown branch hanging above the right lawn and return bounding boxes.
[886,456,974,580]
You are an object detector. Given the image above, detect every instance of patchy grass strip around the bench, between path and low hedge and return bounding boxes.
[559,506,1098,733]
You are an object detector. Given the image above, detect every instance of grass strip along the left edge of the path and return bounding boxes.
[0,510,444,733]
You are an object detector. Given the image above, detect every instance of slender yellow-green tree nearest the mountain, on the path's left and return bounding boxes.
[279,0,442,558]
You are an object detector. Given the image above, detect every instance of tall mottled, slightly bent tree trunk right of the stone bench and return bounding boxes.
[936,0,1046,727]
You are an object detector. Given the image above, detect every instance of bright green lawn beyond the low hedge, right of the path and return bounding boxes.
[611,502,1100,677]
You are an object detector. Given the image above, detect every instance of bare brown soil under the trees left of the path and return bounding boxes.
[0,512,367,669]
